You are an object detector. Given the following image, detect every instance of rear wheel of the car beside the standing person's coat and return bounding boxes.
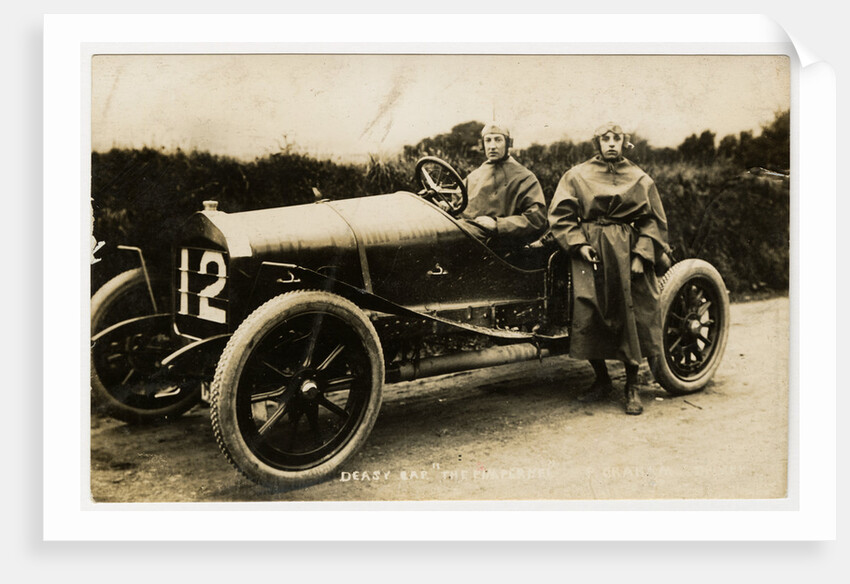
[650,259,729,395]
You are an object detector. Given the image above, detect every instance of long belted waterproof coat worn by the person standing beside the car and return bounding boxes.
[549,156,669,364]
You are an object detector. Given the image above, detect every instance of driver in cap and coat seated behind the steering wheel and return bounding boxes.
[461,124,548,249]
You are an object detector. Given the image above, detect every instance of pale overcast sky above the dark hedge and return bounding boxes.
[91,55,790,160]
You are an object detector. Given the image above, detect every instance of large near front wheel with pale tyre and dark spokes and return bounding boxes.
[210,290,384,490]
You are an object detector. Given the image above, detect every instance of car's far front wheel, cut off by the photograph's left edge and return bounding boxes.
[91,268,201,424]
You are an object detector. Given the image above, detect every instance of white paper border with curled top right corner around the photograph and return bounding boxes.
[43,15,835,541]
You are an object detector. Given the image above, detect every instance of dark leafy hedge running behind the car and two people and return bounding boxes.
[91,112,790,293]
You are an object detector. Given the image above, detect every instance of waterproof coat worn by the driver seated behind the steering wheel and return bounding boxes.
[463,156,547,245]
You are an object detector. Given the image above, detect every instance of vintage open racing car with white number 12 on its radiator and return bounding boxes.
[91,157,729,489]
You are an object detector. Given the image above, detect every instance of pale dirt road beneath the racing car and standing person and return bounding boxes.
[91,298,789,502]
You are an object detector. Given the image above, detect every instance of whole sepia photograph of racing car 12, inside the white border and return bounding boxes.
[83,52,797,504]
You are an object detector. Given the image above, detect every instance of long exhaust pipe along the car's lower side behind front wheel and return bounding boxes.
[386,343,569,383]
